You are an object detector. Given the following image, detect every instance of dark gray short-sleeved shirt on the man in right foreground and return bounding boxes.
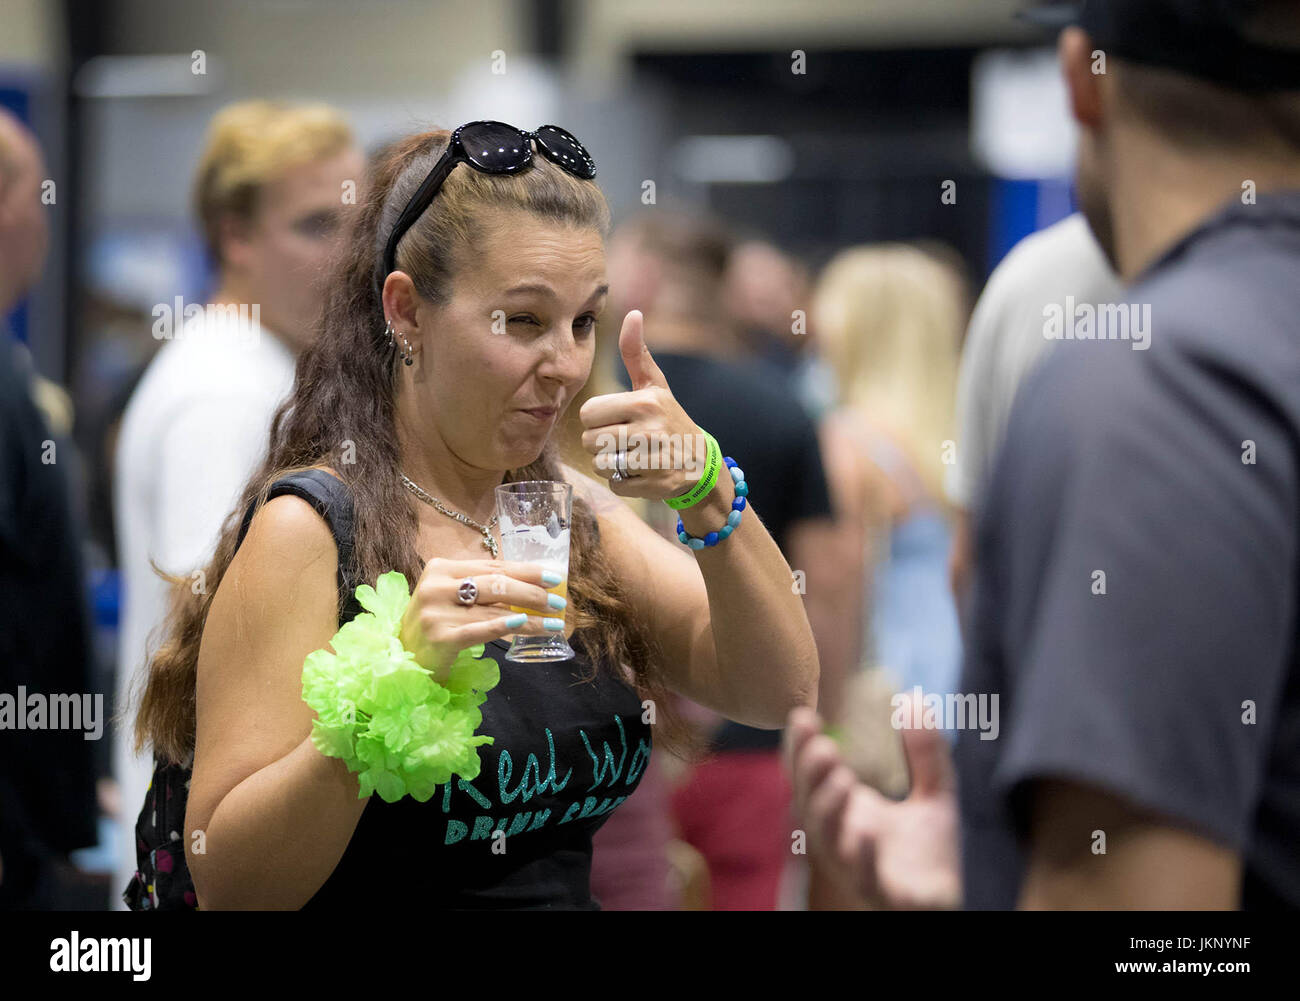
[957,184,1300,909]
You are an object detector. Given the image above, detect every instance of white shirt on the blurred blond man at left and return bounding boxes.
[111,309,295,909]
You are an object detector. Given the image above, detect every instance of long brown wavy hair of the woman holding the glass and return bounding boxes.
[135,130,701,762]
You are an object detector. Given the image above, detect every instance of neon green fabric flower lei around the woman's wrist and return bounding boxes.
[303,571,501,803]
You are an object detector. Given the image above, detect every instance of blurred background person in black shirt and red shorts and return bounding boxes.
[607,207,848,910]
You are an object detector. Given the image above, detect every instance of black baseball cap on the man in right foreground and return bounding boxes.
[1019,0,1300,91]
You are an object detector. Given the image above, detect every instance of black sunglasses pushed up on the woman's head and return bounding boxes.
[384,121,595,277]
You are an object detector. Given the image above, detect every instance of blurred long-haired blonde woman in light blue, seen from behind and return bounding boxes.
[813,244,966,717]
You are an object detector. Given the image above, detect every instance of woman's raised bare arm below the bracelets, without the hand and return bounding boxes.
[563,465,819,729]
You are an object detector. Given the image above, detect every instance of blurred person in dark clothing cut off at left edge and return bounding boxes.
[0,111,100,910]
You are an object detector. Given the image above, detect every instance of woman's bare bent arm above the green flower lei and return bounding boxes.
[185,497,367,910]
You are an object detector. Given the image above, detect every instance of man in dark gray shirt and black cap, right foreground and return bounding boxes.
[788,0,1300,909]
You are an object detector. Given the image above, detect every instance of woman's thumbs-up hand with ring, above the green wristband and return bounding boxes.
[579,309,706,499]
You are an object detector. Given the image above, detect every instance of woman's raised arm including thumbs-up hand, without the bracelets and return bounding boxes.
[579,309,820,729]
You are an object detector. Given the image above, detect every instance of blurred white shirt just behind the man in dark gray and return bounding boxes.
[944,213,1122,508]
